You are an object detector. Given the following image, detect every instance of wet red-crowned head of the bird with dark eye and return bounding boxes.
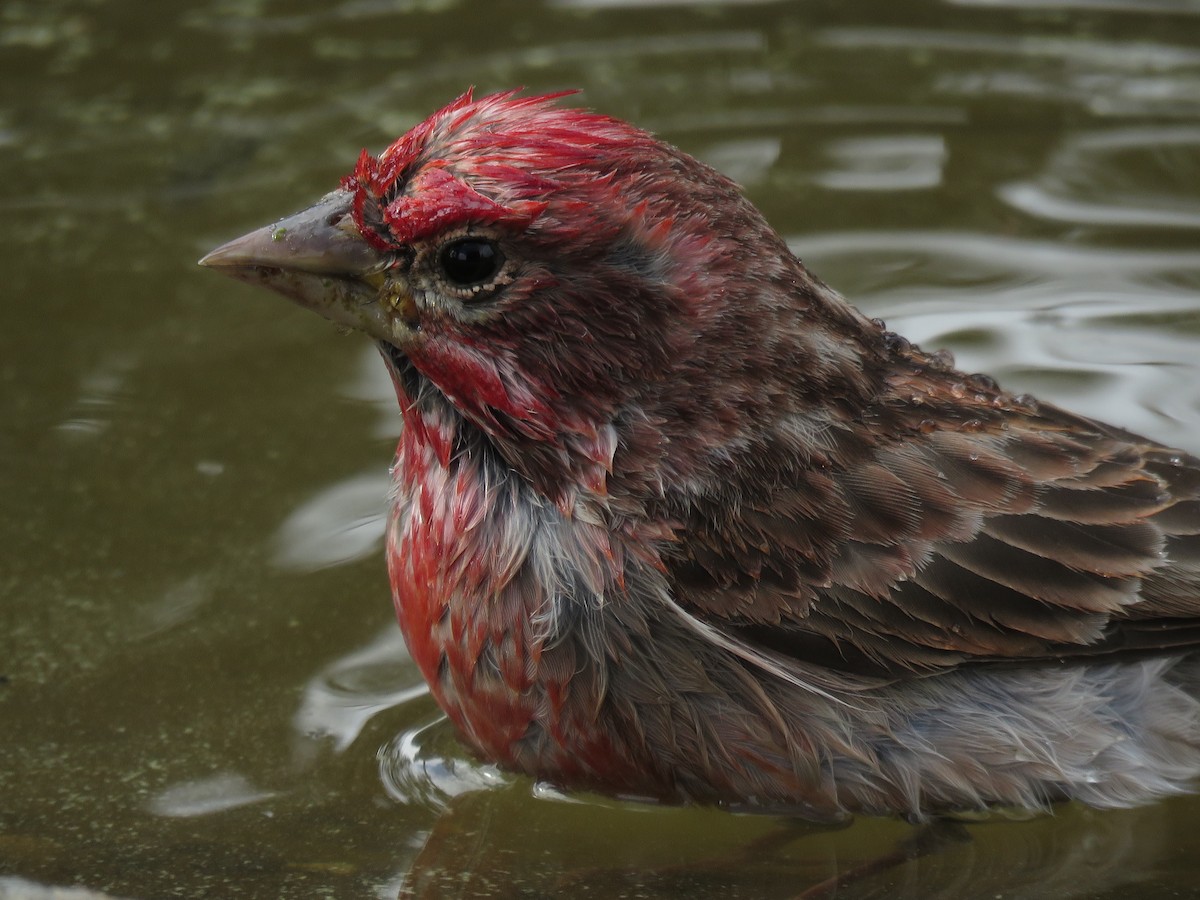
[206,91,877,509]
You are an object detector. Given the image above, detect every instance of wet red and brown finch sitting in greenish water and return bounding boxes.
[204,94,1200,818]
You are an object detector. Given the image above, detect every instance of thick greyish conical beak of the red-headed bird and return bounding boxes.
[200,191,400,341]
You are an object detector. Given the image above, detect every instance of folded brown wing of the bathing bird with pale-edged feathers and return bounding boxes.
[666,385,1200,674]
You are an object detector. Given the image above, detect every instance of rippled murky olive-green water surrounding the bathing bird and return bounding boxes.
[7,0,1200,898]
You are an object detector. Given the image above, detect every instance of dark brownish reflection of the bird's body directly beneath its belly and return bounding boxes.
[400,788,1189,900]
